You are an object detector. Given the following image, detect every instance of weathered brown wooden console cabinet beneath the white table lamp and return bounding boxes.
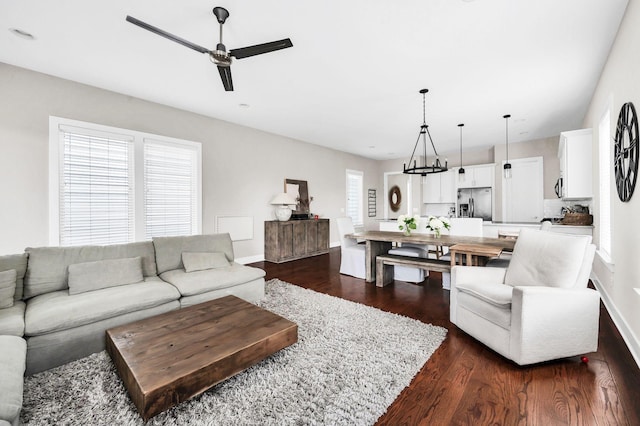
[264,219,329,263]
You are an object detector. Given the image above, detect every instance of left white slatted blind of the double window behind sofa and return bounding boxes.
[59,126,135,246]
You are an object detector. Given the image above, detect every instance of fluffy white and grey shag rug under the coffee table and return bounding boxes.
[21,279,446,426]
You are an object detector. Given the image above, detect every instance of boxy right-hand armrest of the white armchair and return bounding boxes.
[510,286,600,365]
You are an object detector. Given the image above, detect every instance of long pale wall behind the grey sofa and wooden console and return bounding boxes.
[0,63,382,259]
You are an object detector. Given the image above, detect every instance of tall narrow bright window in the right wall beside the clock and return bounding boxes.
[598,103,612,262]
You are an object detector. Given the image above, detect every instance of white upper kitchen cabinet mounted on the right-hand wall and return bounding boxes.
[558,129,593,199]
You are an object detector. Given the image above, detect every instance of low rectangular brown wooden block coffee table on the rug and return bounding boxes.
[106,296,298,420]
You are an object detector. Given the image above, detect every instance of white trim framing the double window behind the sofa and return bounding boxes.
[48,116,202,246]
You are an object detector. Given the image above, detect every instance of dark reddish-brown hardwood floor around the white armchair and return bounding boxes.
[252,248,640,426]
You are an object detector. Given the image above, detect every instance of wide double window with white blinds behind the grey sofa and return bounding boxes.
[49,117,202,246]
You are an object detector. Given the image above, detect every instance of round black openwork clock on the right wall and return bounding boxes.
[613,102,638,202]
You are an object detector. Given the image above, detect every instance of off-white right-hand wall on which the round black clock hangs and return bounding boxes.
[584,0,640,365]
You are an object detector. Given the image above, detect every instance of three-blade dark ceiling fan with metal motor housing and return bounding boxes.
[127,7,293,92]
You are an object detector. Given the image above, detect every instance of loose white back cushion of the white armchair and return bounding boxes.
[505,229,591,288]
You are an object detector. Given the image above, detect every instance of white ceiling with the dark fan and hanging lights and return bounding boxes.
[0,0,627,159]
